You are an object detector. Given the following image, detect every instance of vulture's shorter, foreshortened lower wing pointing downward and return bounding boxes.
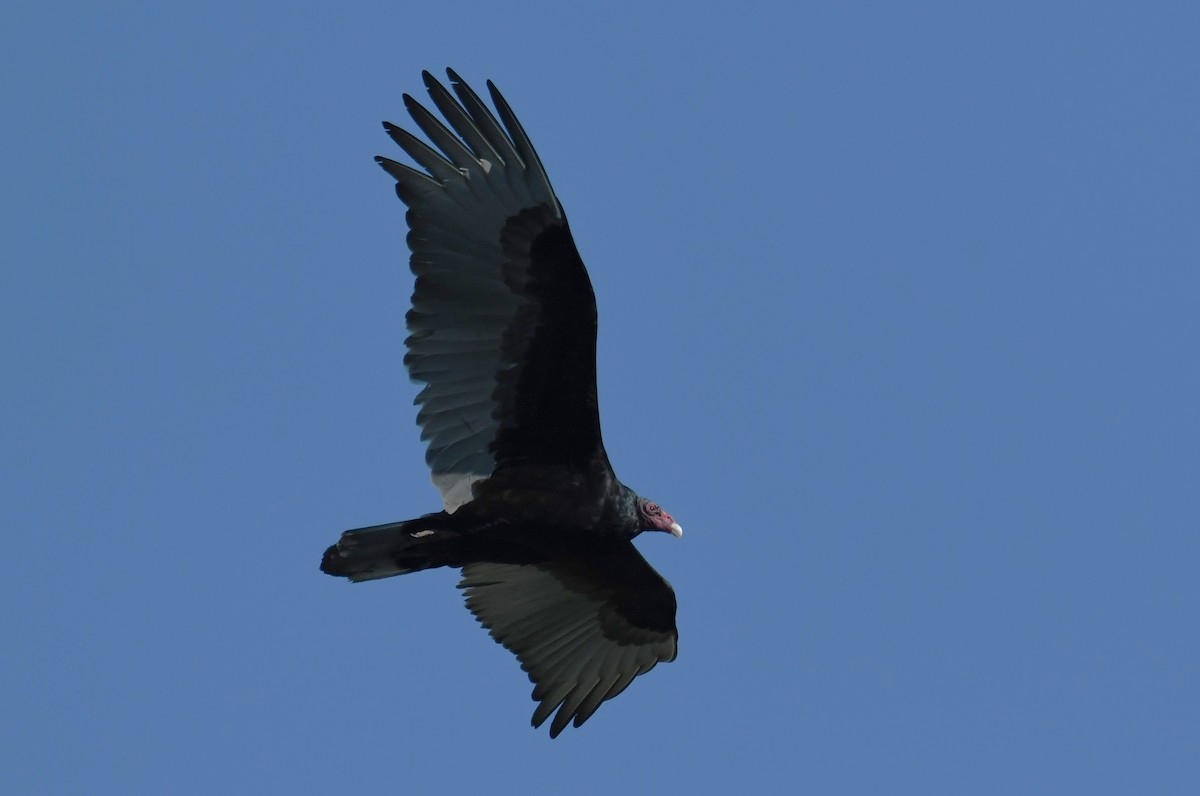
[458,543,679,737]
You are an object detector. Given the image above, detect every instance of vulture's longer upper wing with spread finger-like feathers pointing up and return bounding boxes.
[376,70,607,511]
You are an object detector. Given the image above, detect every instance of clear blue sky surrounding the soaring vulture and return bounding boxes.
[0,1,1200,796]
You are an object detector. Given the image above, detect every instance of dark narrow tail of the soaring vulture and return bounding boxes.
[320,511,463,582]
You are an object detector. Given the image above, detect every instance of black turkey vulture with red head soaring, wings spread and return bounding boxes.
[320,70,683,737]
